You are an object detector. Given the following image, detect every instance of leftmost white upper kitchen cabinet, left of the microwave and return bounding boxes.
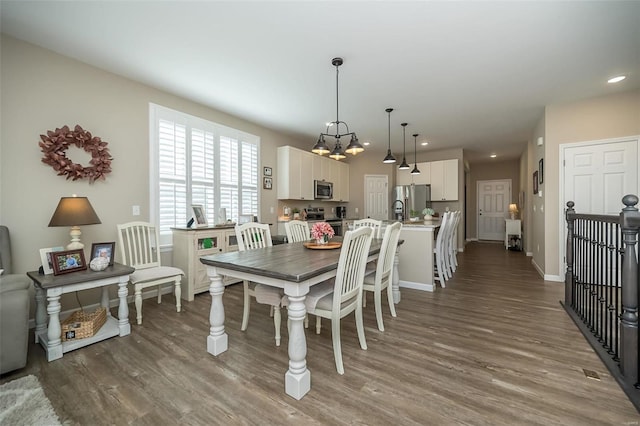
[276,146,316,200]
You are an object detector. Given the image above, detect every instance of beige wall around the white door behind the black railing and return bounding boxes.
[534,90,640,277]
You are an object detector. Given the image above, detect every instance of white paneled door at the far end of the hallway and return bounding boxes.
[477,179,511,241]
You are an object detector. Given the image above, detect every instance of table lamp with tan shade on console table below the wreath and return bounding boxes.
[49,195,102,250]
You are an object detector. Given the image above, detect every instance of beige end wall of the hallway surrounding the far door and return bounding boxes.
[467,160,520,239]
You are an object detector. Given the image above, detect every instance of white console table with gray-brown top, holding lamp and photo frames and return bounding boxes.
[27,263,135,361]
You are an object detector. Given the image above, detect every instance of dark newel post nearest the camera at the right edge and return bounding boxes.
[620,195,638,385]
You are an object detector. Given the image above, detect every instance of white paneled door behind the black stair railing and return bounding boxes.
[558,136,640,276]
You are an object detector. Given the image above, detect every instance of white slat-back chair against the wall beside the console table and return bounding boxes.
[117,222,184,324]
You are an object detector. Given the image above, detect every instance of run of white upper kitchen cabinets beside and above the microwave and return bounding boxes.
[276,146,349,202]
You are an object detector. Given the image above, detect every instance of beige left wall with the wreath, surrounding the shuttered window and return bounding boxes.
[0,35,305,312]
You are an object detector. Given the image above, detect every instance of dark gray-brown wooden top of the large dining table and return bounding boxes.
[200,237,382,282]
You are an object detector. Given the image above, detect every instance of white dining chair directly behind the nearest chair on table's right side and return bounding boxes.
[362,222,402,331]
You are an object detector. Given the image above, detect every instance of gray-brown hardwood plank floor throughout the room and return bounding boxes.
[0,243,640,426]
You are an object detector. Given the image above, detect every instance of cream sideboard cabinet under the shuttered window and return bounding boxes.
[171,228,238,302]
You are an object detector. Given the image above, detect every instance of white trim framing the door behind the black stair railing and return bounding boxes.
[558,135,640,281]
